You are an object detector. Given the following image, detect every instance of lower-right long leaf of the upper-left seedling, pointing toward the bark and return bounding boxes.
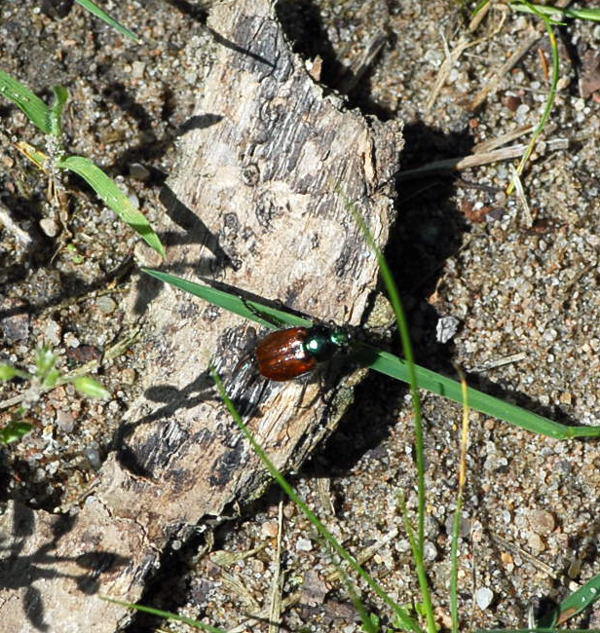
[57,156,165,257]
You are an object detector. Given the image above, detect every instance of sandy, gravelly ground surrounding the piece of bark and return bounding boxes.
[0,0,600,633]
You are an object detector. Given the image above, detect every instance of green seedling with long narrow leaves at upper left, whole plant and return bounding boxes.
[0,70,165,257]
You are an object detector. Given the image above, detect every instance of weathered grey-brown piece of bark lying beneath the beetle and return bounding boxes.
[0,0,402,633]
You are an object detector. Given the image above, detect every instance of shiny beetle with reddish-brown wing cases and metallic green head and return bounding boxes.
[256,324,351,381]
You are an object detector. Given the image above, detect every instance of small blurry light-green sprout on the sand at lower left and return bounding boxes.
[0,347,110,444]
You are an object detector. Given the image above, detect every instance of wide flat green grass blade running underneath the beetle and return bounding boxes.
[142,268,600,439]
